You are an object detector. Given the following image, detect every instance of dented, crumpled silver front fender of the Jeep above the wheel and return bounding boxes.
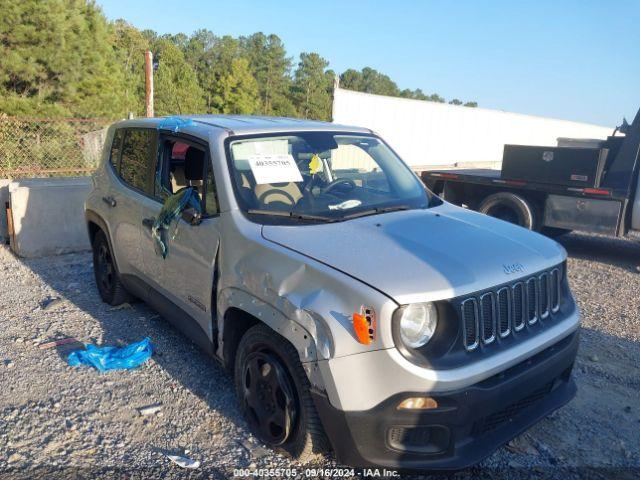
[218,211,398,362]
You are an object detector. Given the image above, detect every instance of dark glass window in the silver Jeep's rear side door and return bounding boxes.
[120,129,155,192]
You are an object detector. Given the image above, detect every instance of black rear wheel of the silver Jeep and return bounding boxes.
[93,230,131,306]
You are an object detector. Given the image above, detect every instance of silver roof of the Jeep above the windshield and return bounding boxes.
[110,115,372,135]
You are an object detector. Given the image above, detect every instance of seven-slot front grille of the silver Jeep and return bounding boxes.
[460,267,562,351]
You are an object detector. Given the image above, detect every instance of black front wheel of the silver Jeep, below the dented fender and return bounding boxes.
[234,324,329,463]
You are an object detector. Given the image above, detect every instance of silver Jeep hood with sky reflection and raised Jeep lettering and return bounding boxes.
[262,203,566,304]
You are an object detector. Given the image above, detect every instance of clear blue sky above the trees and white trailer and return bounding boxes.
[98,0,640,126]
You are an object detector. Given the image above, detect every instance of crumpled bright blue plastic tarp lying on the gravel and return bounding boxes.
[67,337,153,372]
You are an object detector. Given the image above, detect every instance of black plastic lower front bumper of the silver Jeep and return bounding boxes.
[314,332,579,470]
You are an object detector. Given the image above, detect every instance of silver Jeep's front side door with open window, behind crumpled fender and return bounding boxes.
[141,135,220,341]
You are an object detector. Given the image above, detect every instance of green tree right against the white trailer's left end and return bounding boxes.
[292,53,334,120]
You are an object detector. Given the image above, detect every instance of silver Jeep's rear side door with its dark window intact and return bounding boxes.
[104,128,157,276]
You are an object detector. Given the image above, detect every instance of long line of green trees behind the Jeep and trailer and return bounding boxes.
[0,0,477,120]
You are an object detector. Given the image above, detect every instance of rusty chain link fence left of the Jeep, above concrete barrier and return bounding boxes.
[0,116,111,178]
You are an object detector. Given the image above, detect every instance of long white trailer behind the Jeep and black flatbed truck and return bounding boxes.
[333,87,613,171]
